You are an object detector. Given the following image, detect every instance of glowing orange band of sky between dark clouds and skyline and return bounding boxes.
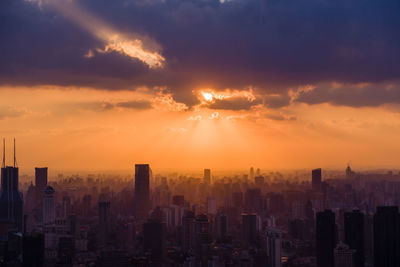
[0,87,400,172]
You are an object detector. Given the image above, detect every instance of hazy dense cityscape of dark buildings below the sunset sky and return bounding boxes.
[0,139,400,267]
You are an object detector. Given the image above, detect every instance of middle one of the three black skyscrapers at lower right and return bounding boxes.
[344,210,365,267]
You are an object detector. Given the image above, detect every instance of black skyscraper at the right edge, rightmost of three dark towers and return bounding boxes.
[374,206,400,267]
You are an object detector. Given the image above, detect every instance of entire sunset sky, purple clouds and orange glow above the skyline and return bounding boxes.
[0,0,400,171]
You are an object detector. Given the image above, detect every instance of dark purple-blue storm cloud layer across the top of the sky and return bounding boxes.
[0,0,400,109]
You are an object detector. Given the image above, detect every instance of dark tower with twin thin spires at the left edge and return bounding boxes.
[0,139,24,231]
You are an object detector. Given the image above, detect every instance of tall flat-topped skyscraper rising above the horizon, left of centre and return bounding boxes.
[135,164,151,221]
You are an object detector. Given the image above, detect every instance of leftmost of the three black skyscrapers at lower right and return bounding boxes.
[316,210,336,267]
